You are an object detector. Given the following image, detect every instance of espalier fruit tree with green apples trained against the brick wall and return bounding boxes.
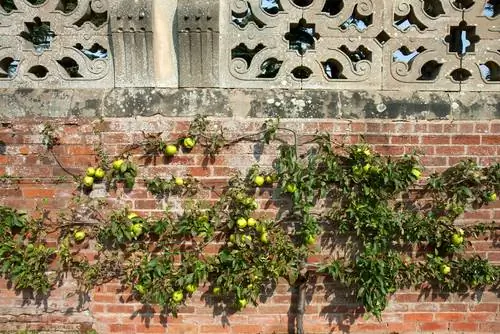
[0,117,500,333]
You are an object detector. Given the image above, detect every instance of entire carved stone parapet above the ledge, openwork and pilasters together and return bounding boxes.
[0,0,500,91]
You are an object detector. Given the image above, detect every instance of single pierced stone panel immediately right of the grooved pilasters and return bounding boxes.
[221,0,382,89]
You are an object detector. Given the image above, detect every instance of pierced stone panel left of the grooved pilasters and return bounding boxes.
[0,0,114,88]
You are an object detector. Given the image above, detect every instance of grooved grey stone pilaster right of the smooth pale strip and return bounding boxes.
[177,0,220,87]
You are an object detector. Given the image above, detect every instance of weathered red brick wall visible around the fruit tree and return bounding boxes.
[0,117,500,334]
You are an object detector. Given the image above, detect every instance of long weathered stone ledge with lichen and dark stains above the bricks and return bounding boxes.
[0,88,500,120]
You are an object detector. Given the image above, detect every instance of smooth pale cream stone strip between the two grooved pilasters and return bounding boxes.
[153,0,178,87]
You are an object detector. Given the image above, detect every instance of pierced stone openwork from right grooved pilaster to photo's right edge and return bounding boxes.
[220,0,500,91]
